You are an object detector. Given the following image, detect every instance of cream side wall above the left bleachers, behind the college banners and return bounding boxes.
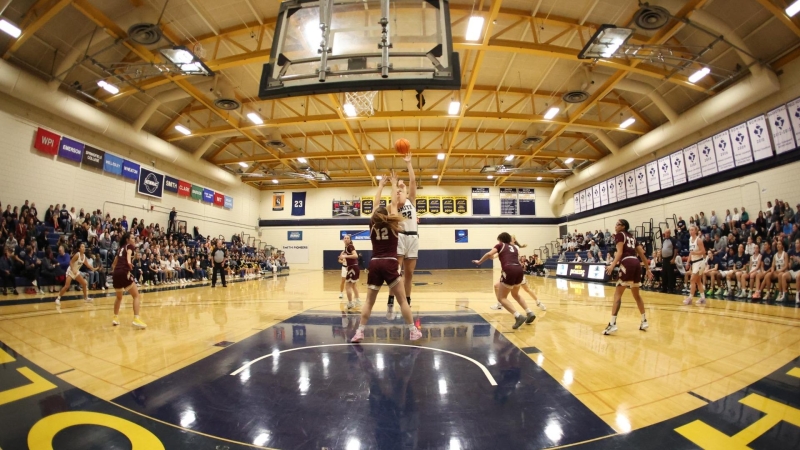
[0,112,261,239]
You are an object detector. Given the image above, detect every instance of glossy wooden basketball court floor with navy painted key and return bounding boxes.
[0,270,800,450]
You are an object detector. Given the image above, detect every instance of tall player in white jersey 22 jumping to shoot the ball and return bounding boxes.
[386,150,419,312]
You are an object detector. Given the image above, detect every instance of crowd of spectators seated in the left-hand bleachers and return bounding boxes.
[0,200,288,295]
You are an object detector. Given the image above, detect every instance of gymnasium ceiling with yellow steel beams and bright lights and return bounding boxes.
[0,0,800,189]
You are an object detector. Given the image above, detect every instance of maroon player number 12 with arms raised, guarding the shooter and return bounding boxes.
[350,172,422,342]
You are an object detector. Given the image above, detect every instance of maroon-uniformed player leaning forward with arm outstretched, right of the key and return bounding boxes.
[472,233,536,330]
